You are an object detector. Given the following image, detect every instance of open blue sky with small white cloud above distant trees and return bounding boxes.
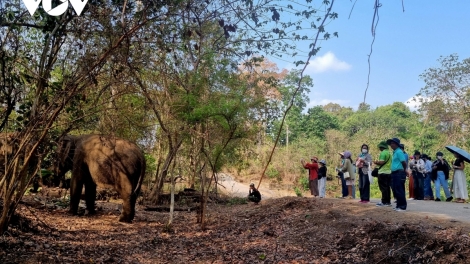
[270,0,470,110]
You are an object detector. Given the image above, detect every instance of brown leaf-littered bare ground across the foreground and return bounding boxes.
[0,193,470,263]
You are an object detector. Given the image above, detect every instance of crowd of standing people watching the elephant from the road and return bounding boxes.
[300,138,468,212]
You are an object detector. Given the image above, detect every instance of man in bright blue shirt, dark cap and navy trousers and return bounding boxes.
[387,138,407,212]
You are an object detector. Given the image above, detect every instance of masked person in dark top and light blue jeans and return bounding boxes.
[432,151,453,202]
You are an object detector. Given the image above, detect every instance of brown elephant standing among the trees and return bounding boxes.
[55,134,146,223]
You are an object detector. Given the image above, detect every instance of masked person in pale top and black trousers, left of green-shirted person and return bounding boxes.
[356,144,372,203]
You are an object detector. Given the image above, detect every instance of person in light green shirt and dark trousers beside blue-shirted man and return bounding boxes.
[374,141,392,206]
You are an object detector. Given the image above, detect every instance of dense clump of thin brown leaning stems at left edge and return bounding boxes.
[0,1,176,233]
